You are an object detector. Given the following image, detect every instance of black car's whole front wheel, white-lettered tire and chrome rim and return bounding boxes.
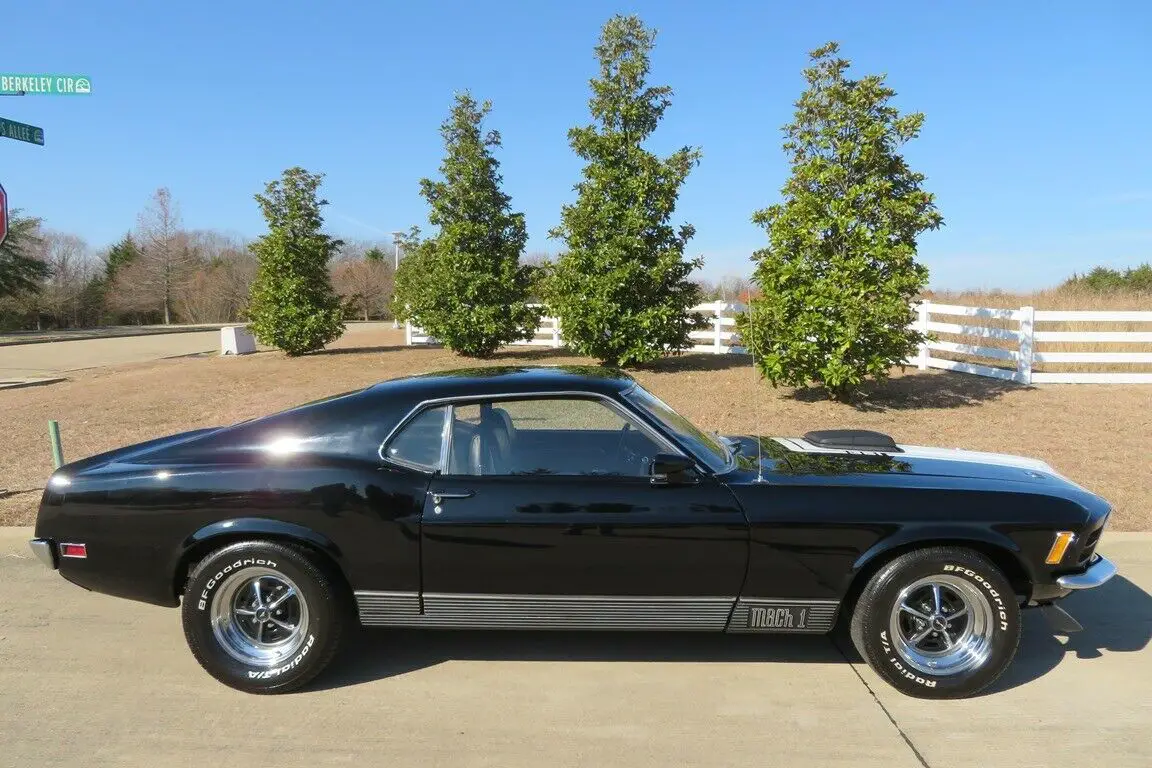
[850,547,1021,699]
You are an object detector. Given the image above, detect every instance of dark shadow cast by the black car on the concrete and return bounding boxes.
[308,576,1152,695]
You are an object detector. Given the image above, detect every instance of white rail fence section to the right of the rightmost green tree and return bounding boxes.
[912,302,1152,383]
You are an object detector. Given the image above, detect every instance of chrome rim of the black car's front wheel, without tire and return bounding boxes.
[888,573,994,676]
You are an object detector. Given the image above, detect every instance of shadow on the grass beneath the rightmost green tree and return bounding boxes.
[790,372,1032,412]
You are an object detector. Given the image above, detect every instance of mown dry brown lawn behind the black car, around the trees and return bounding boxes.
[0,329,1152,530]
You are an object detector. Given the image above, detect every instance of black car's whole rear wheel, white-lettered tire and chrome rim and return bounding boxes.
[182,541,346,693]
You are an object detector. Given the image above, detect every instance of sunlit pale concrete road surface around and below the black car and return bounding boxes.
[0,529,1152,768]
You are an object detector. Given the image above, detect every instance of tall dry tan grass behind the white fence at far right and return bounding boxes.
[924,288,1152,373]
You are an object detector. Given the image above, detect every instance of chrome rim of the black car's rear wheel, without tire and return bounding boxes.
[212,568,308,667]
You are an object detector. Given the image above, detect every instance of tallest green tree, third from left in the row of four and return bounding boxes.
[546,16,702,365]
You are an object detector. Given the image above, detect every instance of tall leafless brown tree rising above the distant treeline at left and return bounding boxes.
[113,192,195,325]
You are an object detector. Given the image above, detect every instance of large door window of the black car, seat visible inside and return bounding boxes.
[448,397,659,477]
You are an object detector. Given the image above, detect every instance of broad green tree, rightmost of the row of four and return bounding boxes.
[738,43,943,400]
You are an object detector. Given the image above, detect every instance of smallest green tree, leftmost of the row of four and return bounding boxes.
[248,168,344,356]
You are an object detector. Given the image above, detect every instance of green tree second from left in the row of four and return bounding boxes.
[395,93,540,358]
